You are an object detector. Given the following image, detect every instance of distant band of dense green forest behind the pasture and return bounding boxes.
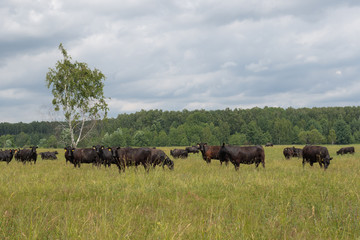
[0,107,360,148]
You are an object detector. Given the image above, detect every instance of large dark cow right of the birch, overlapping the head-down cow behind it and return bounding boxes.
[113,147,155,172]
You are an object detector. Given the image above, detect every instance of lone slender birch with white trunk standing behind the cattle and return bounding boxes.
[46,44,108,147]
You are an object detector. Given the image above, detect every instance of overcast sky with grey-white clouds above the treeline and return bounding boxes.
[0,0,360,122]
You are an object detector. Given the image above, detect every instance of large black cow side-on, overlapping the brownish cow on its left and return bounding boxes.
[219,143,265,170]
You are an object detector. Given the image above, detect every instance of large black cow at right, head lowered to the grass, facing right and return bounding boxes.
[303,145,332,170]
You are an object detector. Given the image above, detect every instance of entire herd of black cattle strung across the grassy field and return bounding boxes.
[0,143,355,172]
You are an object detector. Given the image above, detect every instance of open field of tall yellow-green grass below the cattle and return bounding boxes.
[0,145,360,239]
